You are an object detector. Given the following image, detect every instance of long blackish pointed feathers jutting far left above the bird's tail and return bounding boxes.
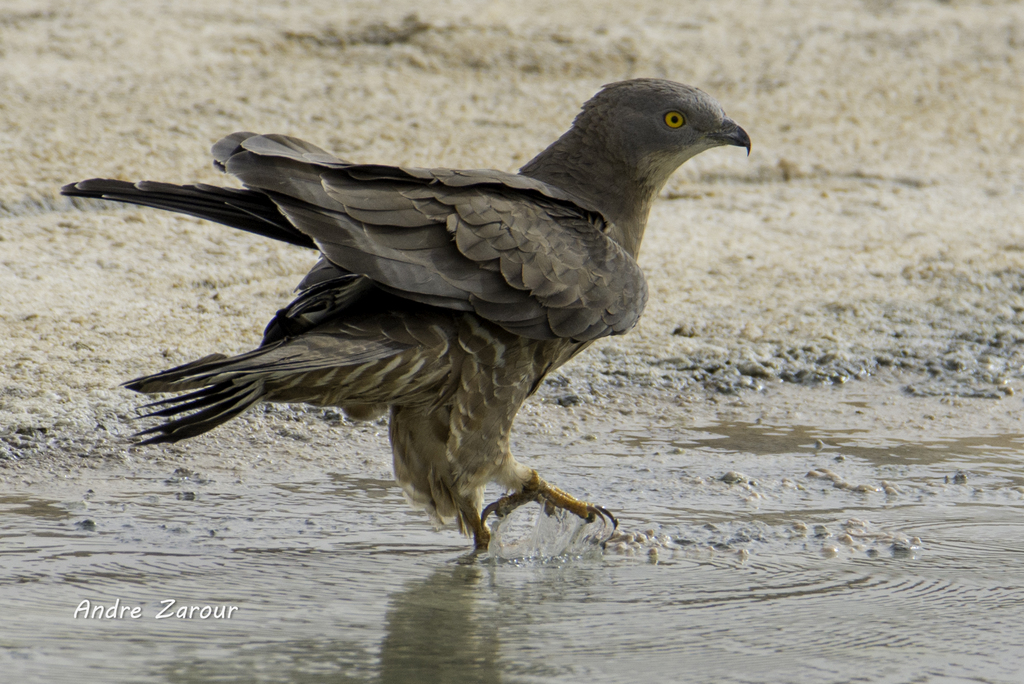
[60,178,316,249]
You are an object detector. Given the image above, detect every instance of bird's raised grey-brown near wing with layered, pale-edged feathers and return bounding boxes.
[214,133,647,341]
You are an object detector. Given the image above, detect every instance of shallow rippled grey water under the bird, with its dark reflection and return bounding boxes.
[0,424,1024,683]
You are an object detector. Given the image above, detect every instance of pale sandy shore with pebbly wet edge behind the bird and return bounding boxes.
[0,0,1024,487]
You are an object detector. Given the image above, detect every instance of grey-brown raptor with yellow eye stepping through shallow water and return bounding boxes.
[61,78,751,550]
